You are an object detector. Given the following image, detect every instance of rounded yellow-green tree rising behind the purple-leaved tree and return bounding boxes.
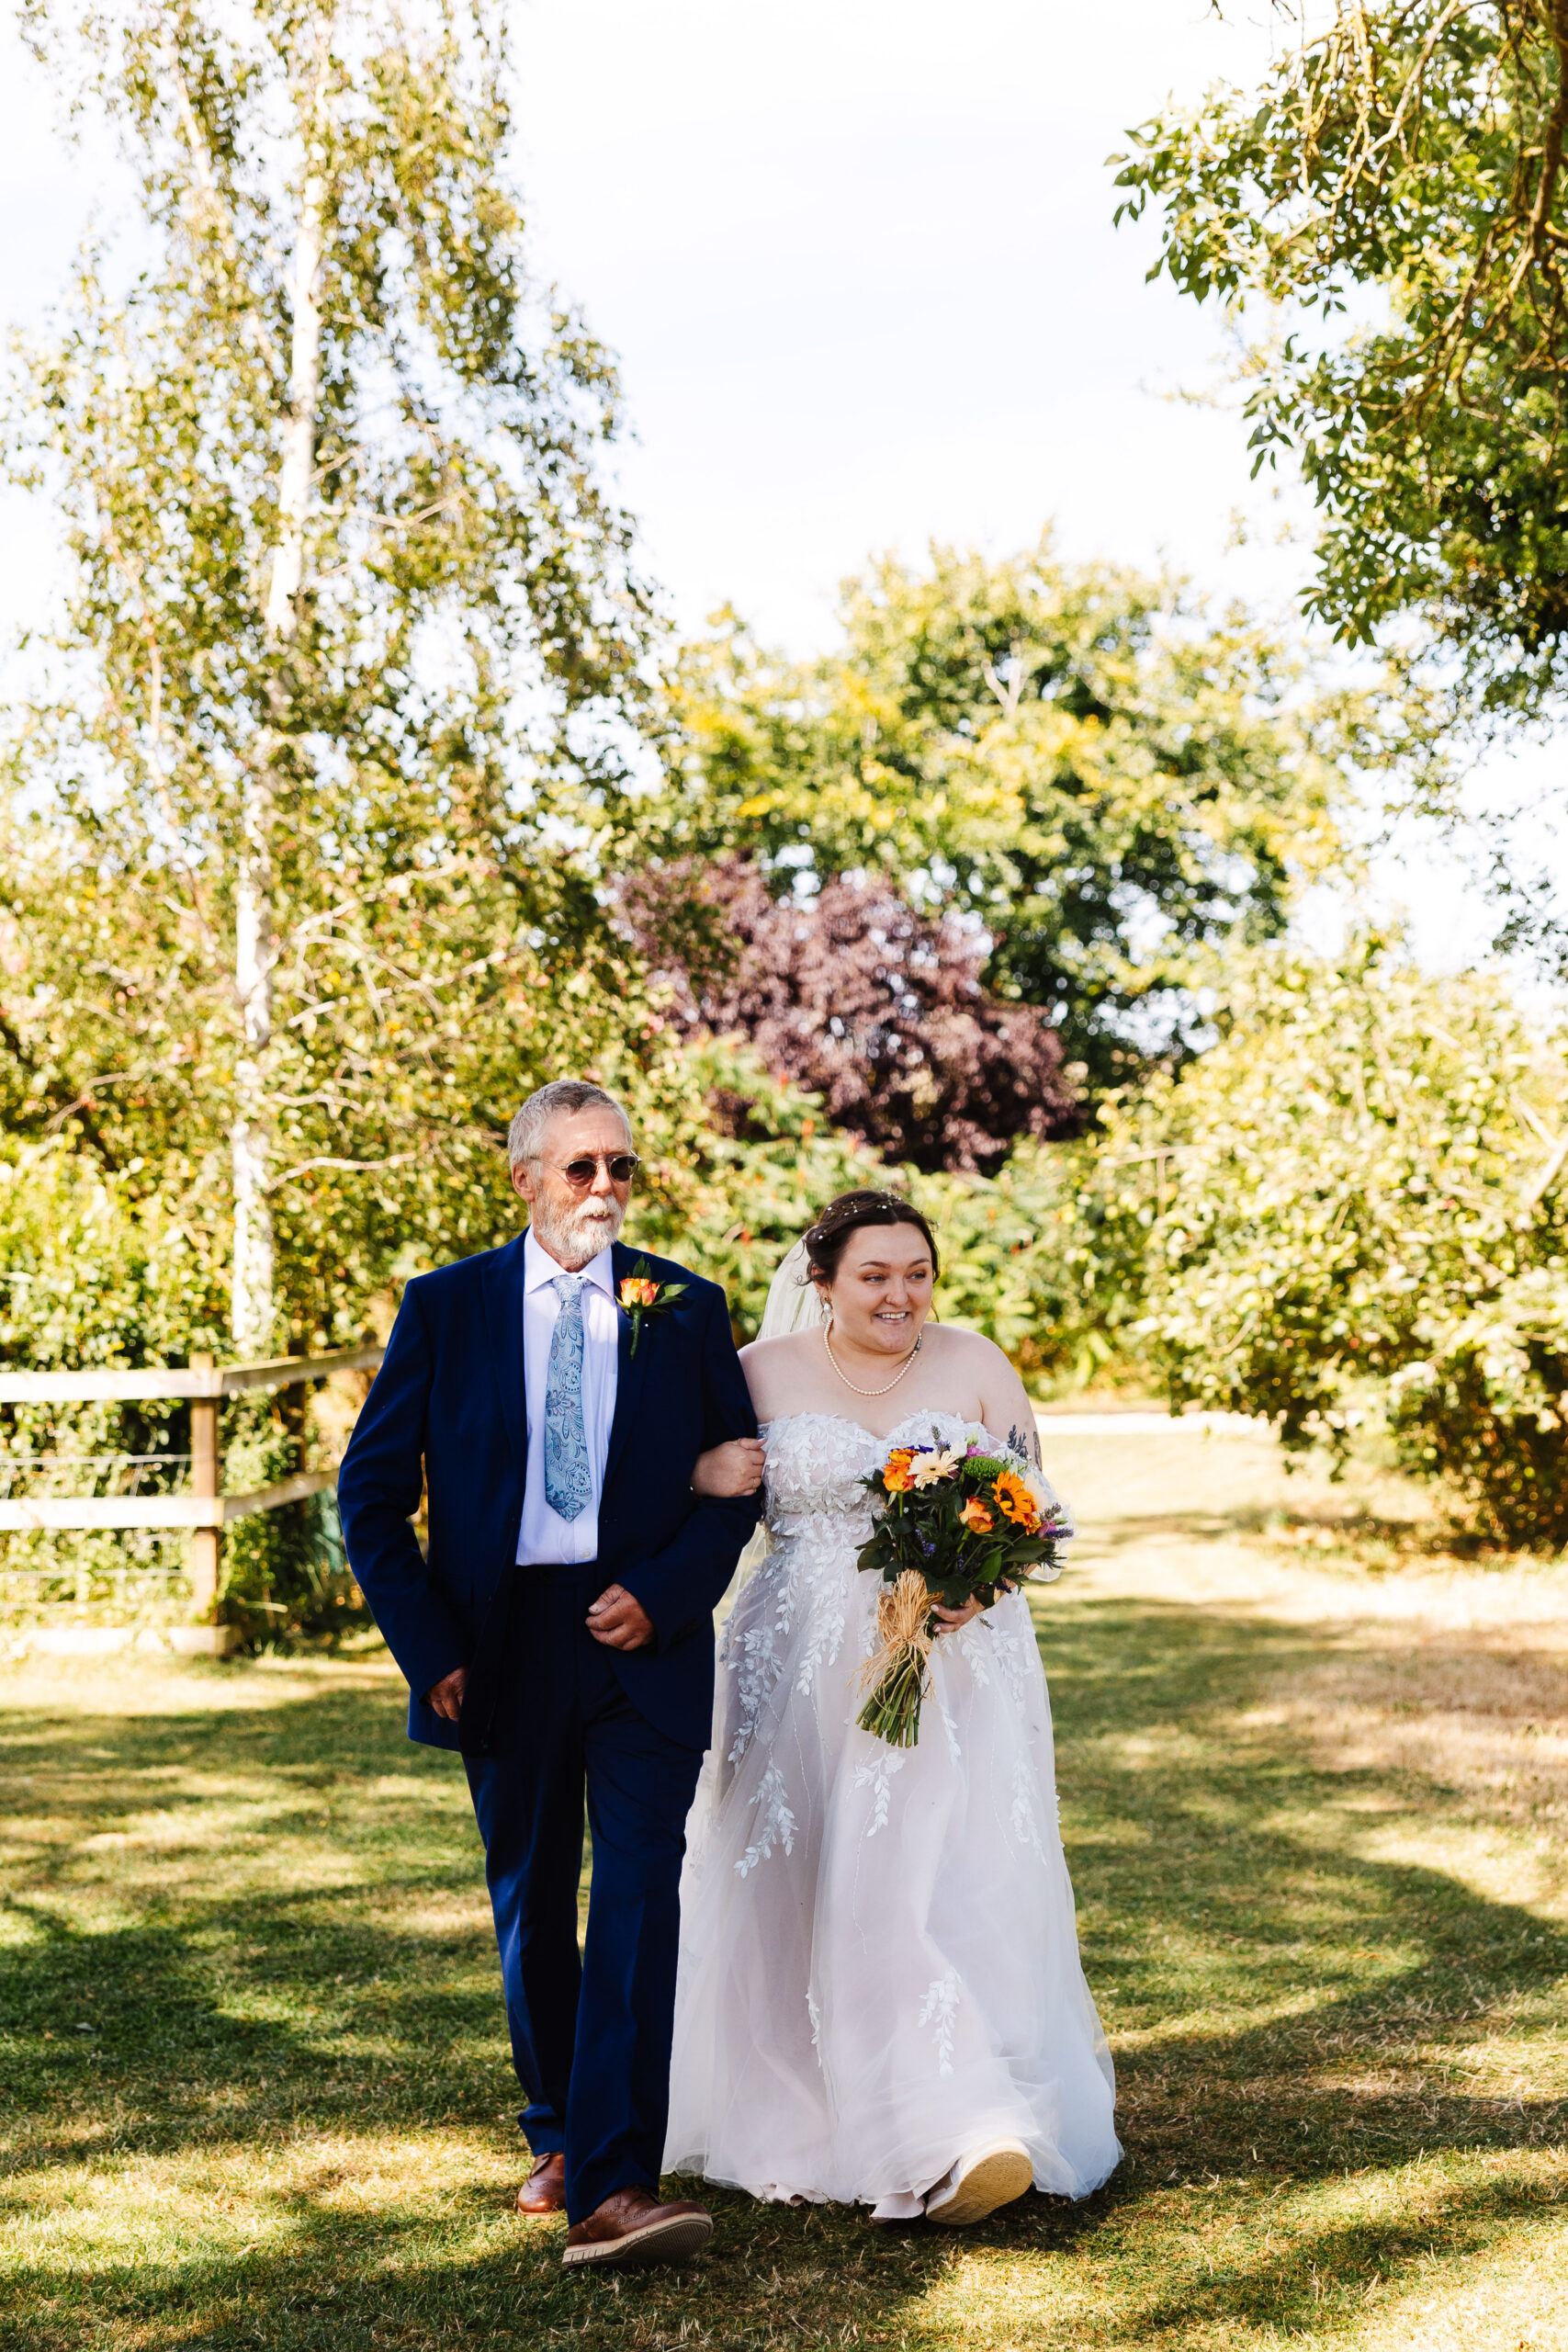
[653,543,1361,1087]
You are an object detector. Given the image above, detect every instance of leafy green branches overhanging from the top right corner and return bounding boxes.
[1114,0,1568,713]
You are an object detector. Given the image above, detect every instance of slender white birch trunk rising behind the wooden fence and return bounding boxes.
[231,78,327,1357]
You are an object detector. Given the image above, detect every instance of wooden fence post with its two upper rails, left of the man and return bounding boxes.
[0,1345,383,1621]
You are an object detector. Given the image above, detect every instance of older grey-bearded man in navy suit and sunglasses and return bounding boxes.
[339,1080,757,2267]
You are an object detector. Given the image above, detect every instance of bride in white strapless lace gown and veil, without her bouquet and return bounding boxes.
[665,1193,1122,2222]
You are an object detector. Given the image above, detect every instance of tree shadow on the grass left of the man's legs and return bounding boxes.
[0,1693,503,2162]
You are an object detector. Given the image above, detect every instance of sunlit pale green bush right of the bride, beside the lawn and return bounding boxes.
[1123,938,1568,1545]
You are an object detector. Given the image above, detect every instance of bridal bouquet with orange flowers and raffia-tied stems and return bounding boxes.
[858,1432,1072,1747]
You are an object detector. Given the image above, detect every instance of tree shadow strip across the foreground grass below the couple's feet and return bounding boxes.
[0,2173,1550,2352]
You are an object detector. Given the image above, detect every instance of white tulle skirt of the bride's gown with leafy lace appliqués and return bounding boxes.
[665,1458,1122,2216]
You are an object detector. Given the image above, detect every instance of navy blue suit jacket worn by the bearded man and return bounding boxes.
[339,1235,761,1752]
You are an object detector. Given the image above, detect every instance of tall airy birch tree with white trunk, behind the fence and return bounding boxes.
[0,0,656,1352]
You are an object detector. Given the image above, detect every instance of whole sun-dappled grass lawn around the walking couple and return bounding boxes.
[0,1425,1568,2352]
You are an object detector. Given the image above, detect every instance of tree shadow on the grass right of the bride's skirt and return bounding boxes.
[1042,1601,1568,2061]
